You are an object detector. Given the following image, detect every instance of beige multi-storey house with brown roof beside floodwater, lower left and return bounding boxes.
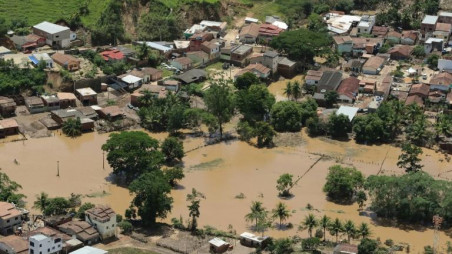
[85,205,116,240]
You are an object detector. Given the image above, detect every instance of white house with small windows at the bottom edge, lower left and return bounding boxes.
[28,234,63,254]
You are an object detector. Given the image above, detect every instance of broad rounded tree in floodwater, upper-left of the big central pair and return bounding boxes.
[102,131,163,181]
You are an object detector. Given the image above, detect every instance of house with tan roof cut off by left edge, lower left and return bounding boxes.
[0,201,24,235]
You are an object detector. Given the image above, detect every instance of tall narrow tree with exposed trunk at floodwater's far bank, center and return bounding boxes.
[204,79,235,139]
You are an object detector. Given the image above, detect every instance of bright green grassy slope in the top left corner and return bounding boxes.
[0,0,110,27]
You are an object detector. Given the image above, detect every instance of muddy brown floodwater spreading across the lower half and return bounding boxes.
[0,132,452,253]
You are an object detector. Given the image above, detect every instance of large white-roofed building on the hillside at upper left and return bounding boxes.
[33,21,71,48]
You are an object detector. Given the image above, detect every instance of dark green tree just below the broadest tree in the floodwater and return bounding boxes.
[129,170,173,226]
